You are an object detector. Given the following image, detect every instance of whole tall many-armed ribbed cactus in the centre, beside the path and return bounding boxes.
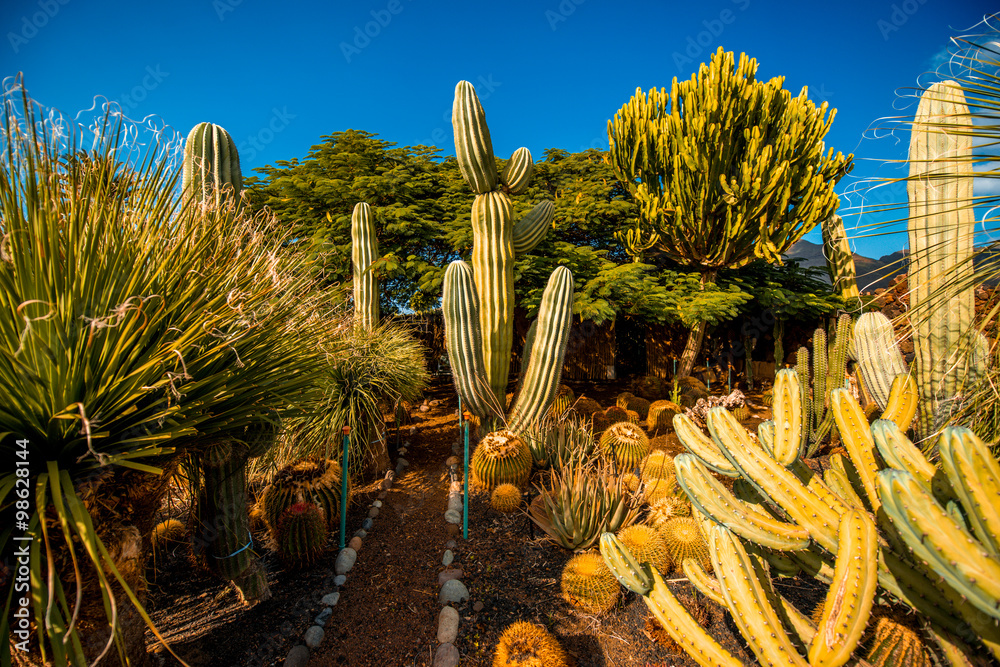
[443,81,573,425]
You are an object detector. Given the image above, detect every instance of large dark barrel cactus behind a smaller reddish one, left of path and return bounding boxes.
[259,457,351,533]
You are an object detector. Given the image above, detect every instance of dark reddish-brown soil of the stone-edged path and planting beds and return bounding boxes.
[148,379,796,667]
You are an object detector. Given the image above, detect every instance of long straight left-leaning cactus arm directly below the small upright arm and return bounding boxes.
[708,408,842,552]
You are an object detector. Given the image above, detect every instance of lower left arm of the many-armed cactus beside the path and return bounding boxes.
[441,260,495,418]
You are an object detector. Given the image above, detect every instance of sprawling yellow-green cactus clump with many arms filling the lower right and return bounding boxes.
[674,371,1000,665]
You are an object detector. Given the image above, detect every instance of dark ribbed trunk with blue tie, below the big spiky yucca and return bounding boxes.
[194,441,271,604]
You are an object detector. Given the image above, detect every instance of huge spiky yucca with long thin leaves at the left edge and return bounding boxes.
[0,81,318,665]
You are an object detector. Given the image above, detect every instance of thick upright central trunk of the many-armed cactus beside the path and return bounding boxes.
[472,192,514,407]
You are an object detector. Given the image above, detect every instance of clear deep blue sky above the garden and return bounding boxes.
[0,0,997,257]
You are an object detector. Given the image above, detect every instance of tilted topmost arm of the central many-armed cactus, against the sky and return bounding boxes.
[451,81,497,195]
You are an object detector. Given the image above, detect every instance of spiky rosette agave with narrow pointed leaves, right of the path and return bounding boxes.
[528,458,641,551]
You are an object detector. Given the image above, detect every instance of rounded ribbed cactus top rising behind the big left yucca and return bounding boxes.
[182,123,243,204]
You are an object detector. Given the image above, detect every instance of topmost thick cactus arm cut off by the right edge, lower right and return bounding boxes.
[938,427,1000,558]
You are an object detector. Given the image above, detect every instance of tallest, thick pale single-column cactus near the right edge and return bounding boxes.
[906,81,975,438]
